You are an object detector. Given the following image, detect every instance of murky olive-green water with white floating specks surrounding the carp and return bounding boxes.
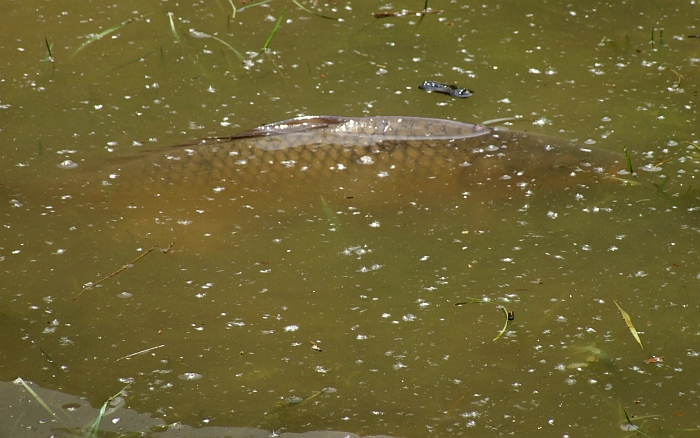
[0,0,700,437]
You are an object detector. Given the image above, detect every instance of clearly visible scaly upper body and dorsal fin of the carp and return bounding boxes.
[103,116,620,197]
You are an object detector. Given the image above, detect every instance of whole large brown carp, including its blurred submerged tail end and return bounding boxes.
[17,116,623,246]
